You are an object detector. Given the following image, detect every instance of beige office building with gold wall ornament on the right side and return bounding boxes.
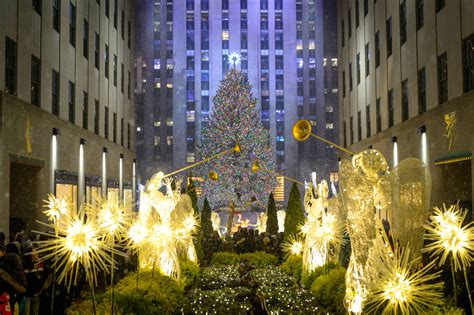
[337,0,474,215]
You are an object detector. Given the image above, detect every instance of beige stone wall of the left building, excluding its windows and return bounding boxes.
[0,0,135,237]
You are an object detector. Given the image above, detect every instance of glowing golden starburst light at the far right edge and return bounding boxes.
[423,204,474,271]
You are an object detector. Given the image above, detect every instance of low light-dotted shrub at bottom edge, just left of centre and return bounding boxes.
[188,287,253,314]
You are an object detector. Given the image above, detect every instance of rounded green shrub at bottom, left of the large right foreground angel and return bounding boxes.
[311,267,346,314]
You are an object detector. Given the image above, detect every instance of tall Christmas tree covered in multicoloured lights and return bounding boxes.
[199,69,275,209]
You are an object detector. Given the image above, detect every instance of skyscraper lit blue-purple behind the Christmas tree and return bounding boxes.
[135,0,338,201]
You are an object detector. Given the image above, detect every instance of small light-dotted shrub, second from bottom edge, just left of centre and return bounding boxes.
[197,266,240,290]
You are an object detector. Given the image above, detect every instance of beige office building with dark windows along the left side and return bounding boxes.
[0,0,135,234]
